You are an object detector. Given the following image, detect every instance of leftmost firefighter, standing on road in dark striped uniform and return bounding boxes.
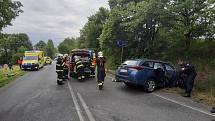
[56,55,64,85]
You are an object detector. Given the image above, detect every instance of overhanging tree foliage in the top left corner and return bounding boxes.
[0,0,23,31]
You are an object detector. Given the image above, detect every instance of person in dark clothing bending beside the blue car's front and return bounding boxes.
[180,62,197,97]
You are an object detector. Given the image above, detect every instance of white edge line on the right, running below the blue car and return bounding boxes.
[152,93,215,117]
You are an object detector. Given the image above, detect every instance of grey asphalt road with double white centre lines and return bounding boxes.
[0,65,215,121]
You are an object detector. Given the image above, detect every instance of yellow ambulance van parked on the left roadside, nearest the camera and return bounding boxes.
[22,51,45,70]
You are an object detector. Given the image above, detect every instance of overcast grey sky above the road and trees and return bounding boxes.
[4,0,108,45]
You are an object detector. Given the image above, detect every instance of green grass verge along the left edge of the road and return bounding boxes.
[0,66,25,87]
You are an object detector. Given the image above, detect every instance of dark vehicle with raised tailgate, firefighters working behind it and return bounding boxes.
[69,49,95,77]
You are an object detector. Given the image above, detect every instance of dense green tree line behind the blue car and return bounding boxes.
[73,0,215,66]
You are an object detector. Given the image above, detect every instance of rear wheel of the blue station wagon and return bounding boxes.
[144,79,156,93]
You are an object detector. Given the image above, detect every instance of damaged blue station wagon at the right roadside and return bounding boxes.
[116,59,177,92]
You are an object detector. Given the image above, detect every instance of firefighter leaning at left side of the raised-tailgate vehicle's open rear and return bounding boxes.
[74,56,85,80]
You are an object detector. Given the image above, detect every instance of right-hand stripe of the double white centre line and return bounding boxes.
[77,93,95,121]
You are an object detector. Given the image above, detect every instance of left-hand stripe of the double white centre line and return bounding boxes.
[67,81,84,121]
